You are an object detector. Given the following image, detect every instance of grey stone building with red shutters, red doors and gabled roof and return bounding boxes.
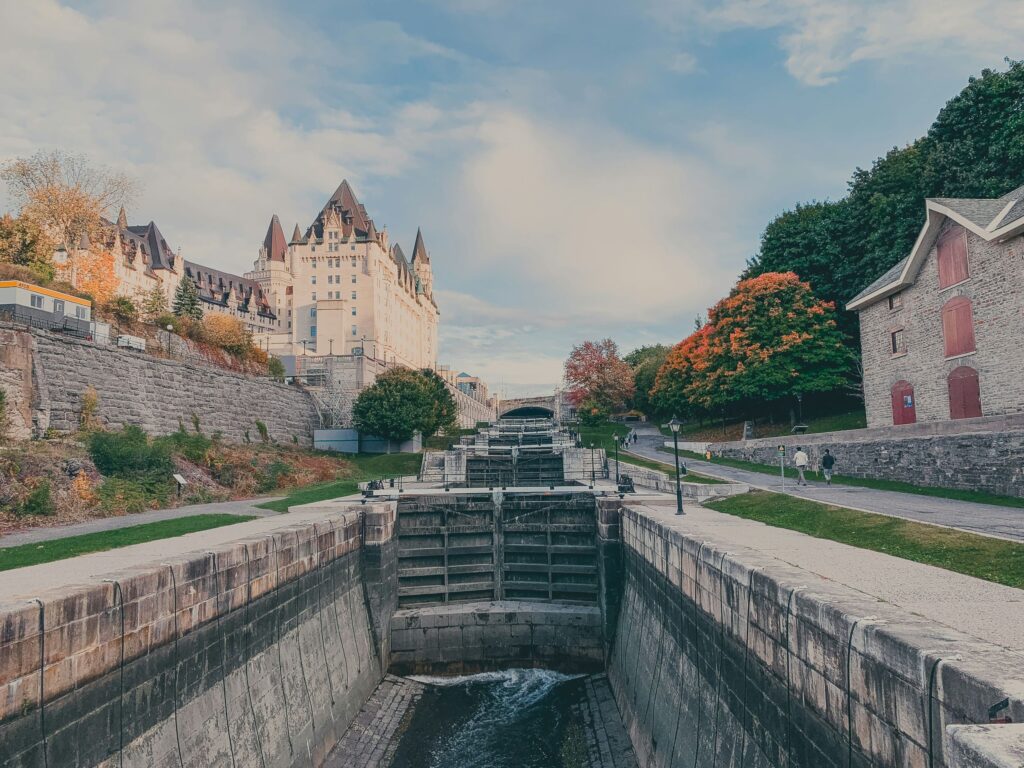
[847,186,1024,427]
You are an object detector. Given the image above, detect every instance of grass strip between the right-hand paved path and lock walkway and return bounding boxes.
[706,490,1024,588]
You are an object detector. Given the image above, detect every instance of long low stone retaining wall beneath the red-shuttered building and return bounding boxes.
[711,416,1024,496]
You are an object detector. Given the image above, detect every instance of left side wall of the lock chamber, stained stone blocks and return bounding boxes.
[0,508,383,768]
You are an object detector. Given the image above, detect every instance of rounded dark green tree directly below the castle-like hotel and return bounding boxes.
[352,368,436,440]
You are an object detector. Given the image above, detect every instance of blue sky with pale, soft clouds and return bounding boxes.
[0,0,1024,396]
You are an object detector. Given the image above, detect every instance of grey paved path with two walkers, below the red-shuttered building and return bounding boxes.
[630,424,1024,542]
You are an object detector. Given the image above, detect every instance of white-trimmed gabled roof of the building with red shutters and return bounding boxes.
[846,186,1024,310]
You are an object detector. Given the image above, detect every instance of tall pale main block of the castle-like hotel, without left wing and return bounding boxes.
[245,181,439,368]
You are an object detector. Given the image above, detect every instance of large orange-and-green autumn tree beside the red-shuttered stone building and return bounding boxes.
[684,272,850,411]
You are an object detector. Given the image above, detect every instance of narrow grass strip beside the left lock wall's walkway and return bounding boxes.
[0,514,255,570]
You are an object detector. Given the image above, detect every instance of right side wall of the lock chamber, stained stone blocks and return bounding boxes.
[608,507,1024,768]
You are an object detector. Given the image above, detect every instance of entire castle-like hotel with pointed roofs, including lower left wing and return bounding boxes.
[99,181,439,368]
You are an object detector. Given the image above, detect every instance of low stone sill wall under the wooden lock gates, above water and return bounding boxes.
[390,600,604,675]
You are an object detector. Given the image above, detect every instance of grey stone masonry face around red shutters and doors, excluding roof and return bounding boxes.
[860,221,1024,427]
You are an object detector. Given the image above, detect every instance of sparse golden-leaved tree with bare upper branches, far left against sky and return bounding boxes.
[0,150,136,258]
